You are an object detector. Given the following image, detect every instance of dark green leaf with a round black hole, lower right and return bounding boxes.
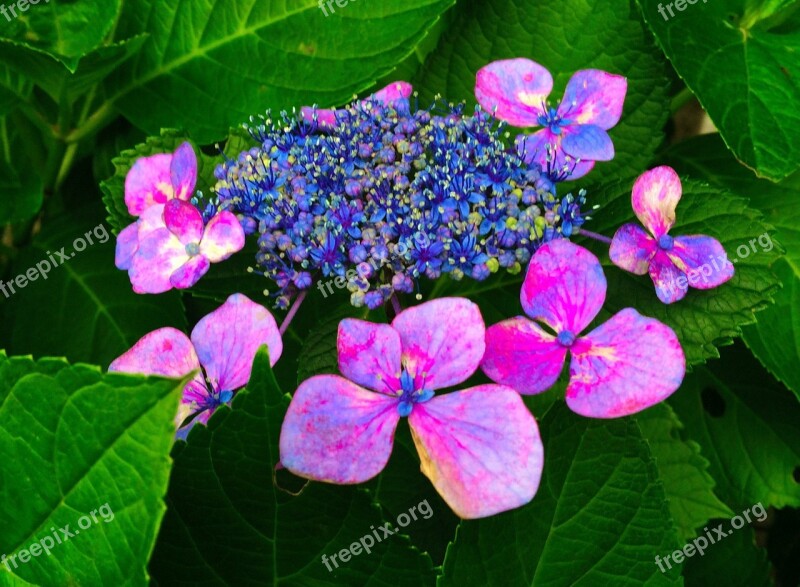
[669,347,800,511]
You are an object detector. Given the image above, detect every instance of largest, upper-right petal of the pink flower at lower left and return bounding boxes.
[192,294,283,391]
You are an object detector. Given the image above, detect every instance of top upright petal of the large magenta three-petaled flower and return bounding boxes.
[520,239,606,336]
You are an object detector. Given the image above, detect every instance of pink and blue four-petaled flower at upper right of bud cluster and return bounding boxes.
[475,58,628,179]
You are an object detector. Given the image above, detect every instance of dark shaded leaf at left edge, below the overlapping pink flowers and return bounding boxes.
[0,208,186,365]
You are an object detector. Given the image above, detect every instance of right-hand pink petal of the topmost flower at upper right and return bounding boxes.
[558,69,628,130]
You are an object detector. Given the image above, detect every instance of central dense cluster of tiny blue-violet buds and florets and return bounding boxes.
[205,82,585,308]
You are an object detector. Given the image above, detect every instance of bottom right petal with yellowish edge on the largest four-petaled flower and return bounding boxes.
[408,385,544,519]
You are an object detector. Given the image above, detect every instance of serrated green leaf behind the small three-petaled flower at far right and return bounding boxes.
[578,179,779,365]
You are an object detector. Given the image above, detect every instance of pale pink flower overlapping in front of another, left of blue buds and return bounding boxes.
[116,199,245,294]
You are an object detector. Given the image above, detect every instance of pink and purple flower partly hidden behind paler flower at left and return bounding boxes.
[125,142,197,216]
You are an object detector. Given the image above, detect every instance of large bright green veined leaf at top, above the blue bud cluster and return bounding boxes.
[106,0,453,143]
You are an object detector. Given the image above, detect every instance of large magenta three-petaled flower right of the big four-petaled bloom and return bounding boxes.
[481,239,686,418]
